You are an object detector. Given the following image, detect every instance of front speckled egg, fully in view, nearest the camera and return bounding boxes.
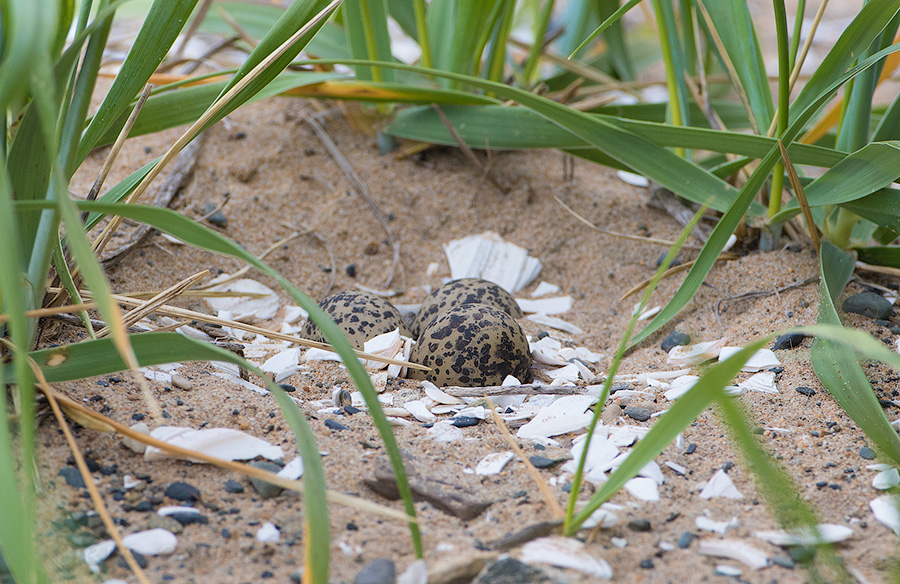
[409,303,532,387]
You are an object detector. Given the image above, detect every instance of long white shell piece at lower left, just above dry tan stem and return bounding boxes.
[144,426,284,462]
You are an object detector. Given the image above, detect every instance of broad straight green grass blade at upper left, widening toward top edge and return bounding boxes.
[75,0,197,167]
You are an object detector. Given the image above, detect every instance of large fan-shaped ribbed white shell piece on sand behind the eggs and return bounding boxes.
[444,231,541,294]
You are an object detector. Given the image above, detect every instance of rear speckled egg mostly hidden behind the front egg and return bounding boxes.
[411,278,525,337]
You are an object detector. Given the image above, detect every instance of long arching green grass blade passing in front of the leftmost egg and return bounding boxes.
[19,201,422,557]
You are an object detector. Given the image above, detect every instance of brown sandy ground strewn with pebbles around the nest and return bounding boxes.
[28,89,896,583]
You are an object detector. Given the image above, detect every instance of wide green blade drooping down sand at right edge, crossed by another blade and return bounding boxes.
[810,242,900,464]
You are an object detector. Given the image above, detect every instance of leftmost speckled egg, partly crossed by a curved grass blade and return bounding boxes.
[303,290,412,351]
